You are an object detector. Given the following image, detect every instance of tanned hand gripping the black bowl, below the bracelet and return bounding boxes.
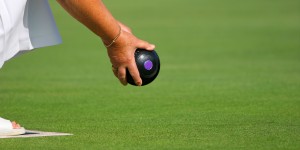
[107,27,155,86]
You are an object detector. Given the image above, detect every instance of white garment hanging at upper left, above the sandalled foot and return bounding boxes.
[0,0,61,68]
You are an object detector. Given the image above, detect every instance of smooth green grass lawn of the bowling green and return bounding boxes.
[0,0,300,150]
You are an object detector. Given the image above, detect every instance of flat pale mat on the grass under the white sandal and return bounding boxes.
[0,130,73,139]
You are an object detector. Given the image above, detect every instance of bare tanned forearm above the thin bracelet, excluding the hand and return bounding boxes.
[57,0,120,45]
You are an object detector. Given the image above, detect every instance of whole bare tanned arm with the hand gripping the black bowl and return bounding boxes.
[57,0,155,85]
